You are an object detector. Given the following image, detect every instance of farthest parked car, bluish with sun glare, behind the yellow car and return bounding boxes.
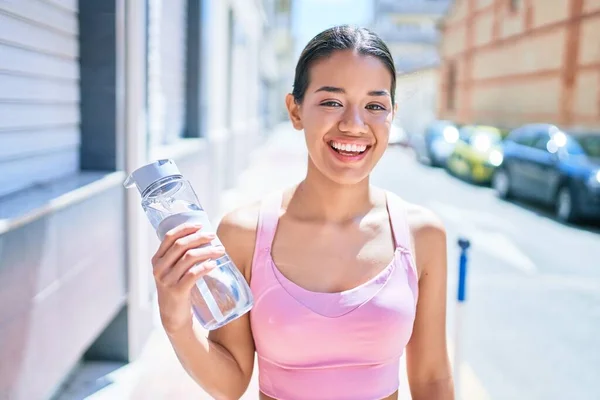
[411,120,458,167]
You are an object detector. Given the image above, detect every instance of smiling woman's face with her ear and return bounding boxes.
[288,50,395,184]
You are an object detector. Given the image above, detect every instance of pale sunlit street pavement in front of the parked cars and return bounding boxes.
[373,148,600,400]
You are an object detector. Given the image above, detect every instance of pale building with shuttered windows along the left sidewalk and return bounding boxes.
[0,0,284,400]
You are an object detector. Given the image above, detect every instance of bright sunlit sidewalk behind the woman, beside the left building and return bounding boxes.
[68,124,410,400]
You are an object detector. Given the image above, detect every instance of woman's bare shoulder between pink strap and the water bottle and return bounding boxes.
[217,201,260,281]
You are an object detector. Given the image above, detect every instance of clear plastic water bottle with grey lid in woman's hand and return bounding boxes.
[124,160,253,330]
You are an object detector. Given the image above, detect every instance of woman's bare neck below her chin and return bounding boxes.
[288,161,375,223]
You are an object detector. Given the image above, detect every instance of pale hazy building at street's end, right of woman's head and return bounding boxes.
[372,0,452,134]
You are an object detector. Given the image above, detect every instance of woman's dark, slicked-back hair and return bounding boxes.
[292,25,396,104]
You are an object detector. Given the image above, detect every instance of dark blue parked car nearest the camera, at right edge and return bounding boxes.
[492,124,600,222]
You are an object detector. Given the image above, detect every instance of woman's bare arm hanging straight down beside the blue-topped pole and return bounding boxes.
[406,208,454,400]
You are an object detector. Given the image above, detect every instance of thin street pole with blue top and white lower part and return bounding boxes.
[454,238,471,400]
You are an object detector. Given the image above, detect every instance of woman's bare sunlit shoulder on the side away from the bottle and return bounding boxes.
[386,194,446,276]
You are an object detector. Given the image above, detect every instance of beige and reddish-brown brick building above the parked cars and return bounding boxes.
[438,0,600,128]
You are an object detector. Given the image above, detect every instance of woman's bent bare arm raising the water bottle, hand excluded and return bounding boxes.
[156,209,257,400]
